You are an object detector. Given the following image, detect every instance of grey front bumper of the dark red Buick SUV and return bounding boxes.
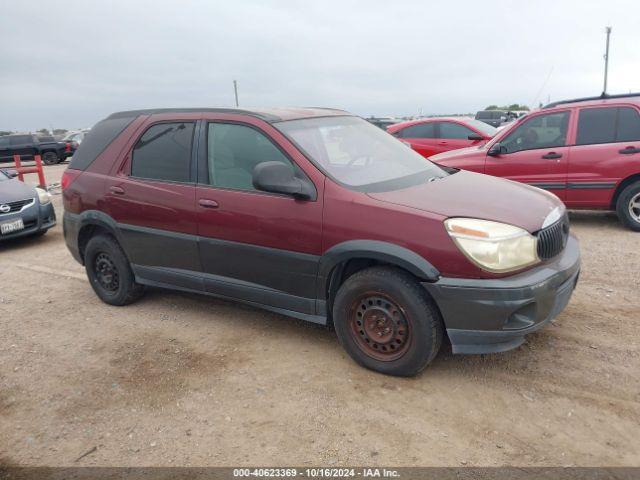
[423,236,580,353]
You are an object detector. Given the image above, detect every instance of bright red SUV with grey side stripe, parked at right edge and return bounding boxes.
[430,94,640,231]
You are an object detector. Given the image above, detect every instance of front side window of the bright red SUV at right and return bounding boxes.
[500,111,569,153]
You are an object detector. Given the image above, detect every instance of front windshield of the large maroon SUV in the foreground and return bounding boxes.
[275,116,447,188]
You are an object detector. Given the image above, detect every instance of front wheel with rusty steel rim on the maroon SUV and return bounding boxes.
[333,267,444,376]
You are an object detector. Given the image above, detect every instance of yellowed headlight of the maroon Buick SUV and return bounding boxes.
[444,218,540,273]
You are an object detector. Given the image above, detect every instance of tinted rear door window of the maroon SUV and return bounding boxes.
[128,122,194,182]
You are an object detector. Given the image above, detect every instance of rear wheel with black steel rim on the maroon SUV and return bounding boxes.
[84,234,144,306]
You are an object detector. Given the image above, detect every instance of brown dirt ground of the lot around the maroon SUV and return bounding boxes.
[0,165,640,466]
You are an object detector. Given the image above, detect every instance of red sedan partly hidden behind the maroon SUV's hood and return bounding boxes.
[387,117,498,158]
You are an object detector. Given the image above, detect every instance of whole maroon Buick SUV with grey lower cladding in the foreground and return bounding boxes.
[62,109,580,375]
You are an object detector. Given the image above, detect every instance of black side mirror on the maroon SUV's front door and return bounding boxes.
[252,162,316,200]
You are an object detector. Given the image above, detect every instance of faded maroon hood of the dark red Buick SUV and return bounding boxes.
[369,170,564,233]
